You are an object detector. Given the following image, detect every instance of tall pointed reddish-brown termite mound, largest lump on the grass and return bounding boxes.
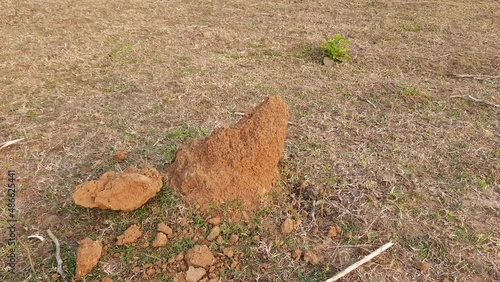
[167,96,288,208]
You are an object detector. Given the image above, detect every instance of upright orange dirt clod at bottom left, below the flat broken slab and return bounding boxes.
[75,238,102,280]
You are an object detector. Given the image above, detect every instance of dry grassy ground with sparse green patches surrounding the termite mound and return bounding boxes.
[0,0,500,281]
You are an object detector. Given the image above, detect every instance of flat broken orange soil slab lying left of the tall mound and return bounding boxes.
[73,167,163,211]
